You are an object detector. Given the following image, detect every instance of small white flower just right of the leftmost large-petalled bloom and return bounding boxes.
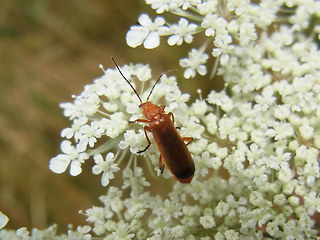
[92,152,120,187]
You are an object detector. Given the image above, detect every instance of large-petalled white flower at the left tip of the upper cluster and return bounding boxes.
[126,14,165,49]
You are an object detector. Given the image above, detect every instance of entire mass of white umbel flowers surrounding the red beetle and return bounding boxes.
[0,0,320,240]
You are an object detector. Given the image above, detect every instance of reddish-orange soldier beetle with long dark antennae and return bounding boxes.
[112,58,195,183]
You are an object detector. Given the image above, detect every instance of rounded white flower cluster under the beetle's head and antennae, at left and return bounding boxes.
[50,64,196,186]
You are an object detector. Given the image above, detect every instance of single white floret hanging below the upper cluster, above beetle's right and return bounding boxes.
[180,49,209,78]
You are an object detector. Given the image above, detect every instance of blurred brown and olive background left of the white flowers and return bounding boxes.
[0,0,216,232]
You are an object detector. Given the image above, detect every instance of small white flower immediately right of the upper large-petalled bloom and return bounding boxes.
[168,18,197,46]
